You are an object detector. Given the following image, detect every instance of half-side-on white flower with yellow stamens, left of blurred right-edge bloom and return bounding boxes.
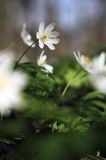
[73,51,93,73]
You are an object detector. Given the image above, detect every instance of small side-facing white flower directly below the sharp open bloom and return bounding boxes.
[37,50,53,73]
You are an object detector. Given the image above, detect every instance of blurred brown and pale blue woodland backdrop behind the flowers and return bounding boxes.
[0,0,106,57]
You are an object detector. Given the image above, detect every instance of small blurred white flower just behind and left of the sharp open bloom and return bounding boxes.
[21,24,35,47]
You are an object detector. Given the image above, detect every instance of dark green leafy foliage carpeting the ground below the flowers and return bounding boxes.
[0,57,106,160]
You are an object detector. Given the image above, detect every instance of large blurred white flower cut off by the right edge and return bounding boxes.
[89,52,106,94]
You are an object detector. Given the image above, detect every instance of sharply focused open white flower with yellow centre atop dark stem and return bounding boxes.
[36,23,60,50]
